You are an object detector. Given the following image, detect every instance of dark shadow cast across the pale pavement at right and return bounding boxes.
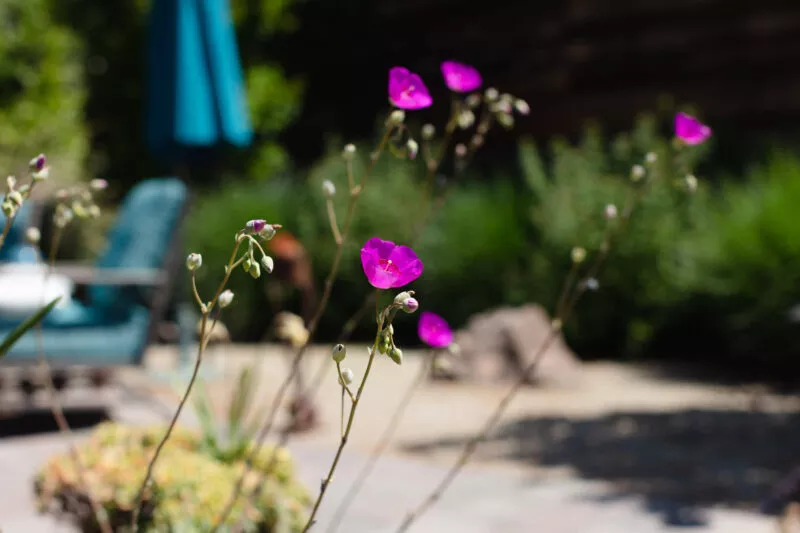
[406,409,800,526]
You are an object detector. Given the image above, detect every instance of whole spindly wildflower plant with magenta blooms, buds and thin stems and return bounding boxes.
[51,55,711,532]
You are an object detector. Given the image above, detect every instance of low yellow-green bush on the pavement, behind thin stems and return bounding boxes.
[35,422,309,533]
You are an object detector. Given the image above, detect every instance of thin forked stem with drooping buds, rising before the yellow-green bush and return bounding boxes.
[131,238,242,533]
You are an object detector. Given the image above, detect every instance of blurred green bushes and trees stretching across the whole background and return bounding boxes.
[0,0,800,368]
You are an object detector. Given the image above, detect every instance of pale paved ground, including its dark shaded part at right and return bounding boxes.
[0,347,788,533]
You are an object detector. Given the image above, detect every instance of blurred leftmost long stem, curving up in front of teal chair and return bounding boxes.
[32,225,112,533]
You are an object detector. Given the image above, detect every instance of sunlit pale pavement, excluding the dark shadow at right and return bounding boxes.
[0,342,774,533]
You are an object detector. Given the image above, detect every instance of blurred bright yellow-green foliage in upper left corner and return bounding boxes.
[0,0,87,193]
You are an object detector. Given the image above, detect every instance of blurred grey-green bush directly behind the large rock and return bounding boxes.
[520,116,711,356]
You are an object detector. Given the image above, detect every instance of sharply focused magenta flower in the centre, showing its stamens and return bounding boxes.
[361,237,423,289]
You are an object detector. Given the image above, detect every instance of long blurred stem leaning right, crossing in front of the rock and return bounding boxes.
[396,167,652,533]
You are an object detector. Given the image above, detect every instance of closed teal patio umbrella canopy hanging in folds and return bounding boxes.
[147,0,253,163]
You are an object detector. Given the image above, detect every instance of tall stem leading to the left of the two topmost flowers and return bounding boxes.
[211,126,392,533]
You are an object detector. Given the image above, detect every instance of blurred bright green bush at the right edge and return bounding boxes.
[663,151,800,366]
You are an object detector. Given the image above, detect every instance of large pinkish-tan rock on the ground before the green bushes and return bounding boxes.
[434,305,580,385]
